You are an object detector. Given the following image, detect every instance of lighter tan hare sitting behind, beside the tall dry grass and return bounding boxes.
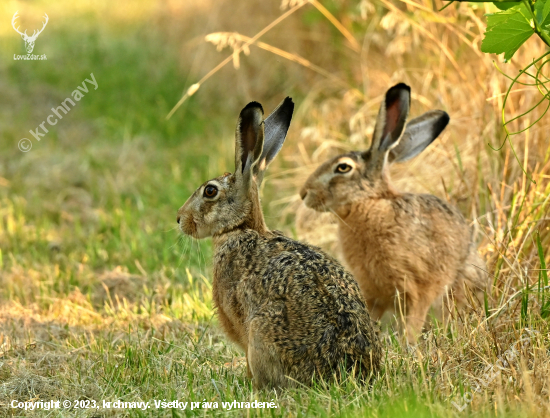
[300,83,487,343]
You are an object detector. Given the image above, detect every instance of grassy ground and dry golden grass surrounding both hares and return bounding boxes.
[0,1,550,417]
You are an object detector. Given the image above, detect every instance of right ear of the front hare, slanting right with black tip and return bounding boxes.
[254,97,294,187]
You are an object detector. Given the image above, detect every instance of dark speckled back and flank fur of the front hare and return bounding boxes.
[219,230,381,380]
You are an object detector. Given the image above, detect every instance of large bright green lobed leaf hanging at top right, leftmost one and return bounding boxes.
[481,4,544,60]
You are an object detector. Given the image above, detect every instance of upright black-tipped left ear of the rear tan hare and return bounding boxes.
[367,83,411,169]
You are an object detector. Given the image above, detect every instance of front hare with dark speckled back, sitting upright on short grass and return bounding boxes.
[177,97,381,388]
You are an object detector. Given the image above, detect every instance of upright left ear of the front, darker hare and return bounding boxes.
[235,102,264,188]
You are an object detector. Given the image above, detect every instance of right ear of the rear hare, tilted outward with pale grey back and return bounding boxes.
[388,110,450,163]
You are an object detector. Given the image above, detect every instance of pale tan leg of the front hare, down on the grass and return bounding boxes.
[247,317,291,389]
